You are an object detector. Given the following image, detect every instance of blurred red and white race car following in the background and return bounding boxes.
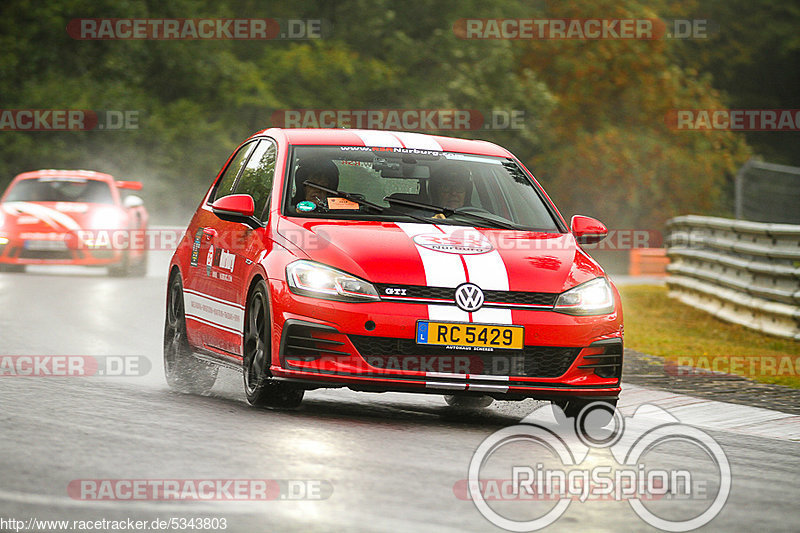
[0,170,148,276]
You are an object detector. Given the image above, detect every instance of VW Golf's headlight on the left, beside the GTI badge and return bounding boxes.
[286,260,380,302]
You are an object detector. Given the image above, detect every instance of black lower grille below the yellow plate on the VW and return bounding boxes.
[349,335,581,378]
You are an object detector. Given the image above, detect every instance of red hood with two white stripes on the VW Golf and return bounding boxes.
[277,218,604,293]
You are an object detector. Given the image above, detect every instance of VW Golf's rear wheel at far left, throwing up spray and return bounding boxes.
[164,274,219,394]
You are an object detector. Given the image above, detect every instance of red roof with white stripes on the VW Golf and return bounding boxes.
[257,128,512,157]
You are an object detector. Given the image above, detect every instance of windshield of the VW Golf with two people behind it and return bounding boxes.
[284,146,559,231]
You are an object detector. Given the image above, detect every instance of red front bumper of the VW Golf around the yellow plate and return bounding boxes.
[271,282,623,399]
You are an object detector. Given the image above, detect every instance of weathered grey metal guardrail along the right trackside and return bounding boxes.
[665,215,800,341]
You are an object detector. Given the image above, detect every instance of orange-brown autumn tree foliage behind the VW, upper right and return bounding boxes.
[522,0,749,230]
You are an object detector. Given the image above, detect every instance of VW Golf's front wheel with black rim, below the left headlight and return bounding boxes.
[242,281,305,408]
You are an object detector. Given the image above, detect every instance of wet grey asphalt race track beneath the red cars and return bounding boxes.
[0,258,800,532]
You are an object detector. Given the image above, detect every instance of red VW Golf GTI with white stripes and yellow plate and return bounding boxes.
[164,129,623,416]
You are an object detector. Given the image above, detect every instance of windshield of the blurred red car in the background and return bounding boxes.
[5,176,114,204]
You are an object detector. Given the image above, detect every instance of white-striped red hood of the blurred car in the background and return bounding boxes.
[0,202,124,232]
